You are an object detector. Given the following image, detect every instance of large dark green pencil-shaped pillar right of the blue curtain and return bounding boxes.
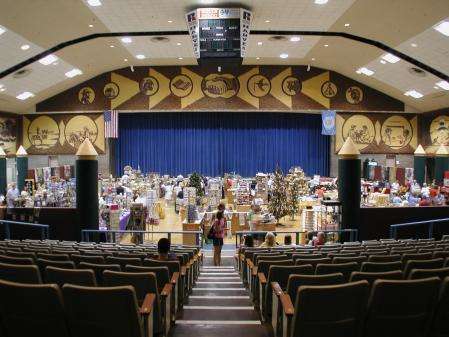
[338,137,361,229]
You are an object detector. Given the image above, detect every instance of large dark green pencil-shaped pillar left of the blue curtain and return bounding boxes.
[75,138,99,240]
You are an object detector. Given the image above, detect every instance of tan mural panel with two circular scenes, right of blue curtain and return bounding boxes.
[335,113,418,153]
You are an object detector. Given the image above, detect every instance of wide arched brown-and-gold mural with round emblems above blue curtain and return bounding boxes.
[36,64,404,112]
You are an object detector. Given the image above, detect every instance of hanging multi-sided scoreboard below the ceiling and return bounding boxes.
[186,8,251,58]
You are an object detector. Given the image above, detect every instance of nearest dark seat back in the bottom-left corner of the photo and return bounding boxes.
[0,280,70,337]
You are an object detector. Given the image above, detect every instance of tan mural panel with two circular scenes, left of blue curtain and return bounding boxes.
[22,113,105,155]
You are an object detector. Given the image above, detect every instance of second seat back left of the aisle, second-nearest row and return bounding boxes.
[45,266,97,287]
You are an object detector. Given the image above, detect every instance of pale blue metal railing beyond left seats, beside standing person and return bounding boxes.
[81,229,203,246]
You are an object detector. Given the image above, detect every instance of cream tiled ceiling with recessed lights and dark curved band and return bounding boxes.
[0,0,449,112]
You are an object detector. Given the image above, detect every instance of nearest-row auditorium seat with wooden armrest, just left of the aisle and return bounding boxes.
[62,284,156,337]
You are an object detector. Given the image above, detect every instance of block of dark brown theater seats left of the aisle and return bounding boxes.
[0,241,202,337]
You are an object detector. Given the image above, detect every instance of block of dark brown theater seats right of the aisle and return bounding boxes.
[236,236,449,336]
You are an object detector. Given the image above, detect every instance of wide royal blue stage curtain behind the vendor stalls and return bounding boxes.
[116,112,330,177]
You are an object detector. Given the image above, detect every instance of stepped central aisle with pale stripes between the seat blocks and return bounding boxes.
[171,250,269,337]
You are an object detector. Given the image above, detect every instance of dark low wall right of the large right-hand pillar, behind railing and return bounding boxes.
[358,206,449,240]
